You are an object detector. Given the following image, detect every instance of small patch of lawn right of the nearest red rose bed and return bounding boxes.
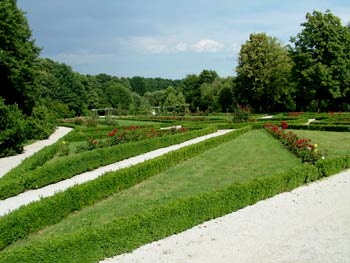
[292,130,350,158]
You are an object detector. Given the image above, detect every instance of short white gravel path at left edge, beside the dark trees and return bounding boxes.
[0,127,72,177]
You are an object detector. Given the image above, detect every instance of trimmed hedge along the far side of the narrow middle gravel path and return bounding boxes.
[0,127,216,200]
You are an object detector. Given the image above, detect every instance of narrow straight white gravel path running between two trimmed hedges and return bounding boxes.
[0,130,232,216]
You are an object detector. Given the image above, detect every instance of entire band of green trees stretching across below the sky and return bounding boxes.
[0,0,350,157]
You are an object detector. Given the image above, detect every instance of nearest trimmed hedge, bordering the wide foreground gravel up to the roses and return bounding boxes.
[0,165,319,263]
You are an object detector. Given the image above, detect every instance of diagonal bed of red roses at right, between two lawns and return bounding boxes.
[264,121,324,164]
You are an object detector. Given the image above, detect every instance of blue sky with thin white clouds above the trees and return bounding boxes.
[17,0,350,79]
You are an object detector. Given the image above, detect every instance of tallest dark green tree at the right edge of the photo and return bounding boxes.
[291,10,350,110]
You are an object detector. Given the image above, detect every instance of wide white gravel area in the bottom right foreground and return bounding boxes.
[101,170,350,263]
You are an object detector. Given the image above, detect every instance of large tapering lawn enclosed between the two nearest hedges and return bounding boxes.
[7,131,300,249]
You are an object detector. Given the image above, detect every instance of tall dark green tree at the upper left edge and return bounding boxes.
[0,0,40,115]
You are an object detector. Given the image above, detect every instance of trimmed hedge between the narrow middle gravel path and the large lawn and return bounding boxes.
[0,127,250,251]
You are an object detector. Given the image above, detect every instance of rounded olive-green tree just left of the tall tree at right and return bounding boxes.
[235,33,294,112]
